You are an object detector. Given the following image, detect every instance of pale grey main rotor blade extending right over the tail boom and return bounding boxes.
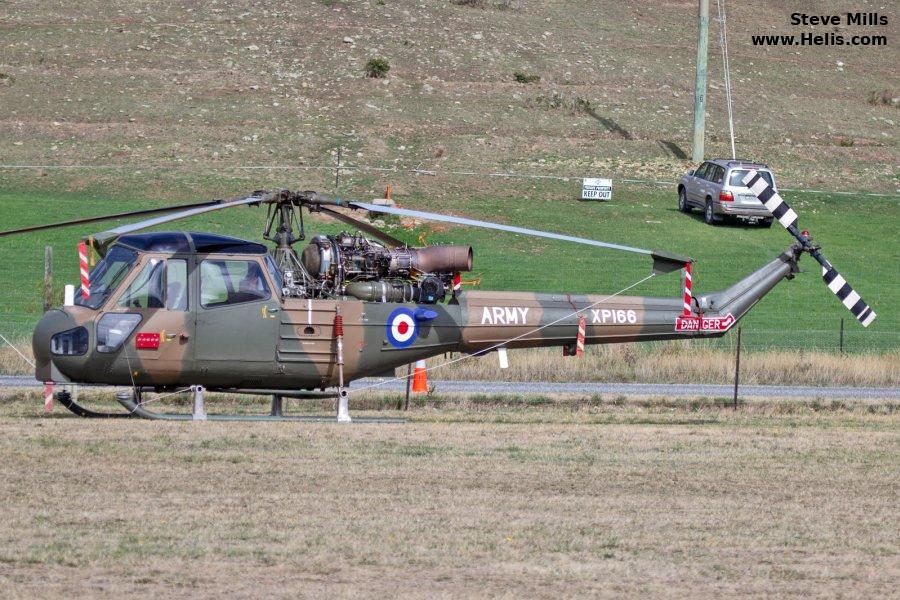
[343,201,692,273]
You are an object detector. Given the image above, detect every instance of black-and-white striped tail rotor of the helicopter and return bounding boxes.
[743,170,877,327]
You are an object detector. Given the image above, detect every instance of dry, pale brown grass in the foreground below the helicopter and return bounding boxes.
[0,394,900,598]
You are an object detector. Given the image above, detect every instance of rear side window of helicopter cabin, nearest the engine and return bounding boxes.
[200,260,271,308]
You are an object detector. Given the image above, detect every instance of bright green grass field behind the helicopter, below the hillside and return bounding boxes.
[0,173,900,350]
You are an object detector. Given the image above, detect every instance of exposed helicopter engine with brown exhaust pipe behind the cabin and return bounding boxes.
[300,232,472,304]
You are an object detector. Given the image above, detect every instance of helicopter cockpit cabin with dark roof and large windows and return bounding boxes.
[33,232,282,381]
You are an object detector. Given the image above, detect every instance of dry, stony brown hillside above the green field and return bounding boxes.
[0,0,900,192]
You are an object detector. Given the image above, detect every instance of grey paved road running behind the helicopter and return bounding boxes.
[0,375,900,400]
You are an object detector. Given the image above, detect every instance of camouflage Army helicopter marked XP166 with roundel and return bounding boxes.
[0,172,875,421]
